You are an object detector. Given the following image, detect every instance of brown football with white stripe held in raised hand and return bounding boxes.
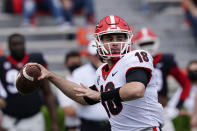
[16,65,41,94]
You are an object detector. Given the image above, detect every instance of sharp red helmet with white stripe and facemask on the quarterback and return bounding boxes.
[95,15,133,59]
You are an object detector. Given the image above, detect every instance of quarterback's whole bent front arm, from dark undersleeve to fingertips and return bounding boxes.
[76,68,151,101]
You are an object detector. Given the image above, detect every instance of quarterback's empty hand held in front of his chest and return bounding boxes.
[74,83,101,101]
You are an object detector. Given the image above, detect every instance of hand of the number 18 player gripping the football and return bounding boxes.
[26,63,51,80]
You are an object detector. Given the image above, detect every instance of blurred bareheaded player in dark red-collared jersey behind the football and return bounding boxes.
[0,34,59,131]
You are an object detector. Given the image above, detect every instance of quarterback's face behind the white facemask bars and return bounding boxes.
[102,33,126,54]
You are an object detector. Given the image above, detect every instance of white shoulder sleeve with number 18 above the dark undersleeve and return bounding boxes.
[124,50,153,82]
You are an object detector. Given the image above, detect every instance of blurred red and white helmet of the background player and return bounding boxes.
[134,28,160,56]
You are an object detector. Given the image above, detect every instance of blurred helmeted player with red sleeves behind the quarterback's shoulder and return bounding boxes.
[134,28,191,130]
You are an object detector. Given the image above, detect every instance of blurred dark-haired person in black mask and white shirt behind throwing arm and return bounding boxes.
[57,51,82,131]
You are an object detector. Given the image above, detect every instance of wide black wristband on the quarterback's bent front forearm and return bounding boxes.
[101,87,122,101]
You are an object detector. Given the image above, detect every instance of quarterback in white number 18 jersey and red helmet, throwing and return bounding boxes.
[29,15,164,131]
